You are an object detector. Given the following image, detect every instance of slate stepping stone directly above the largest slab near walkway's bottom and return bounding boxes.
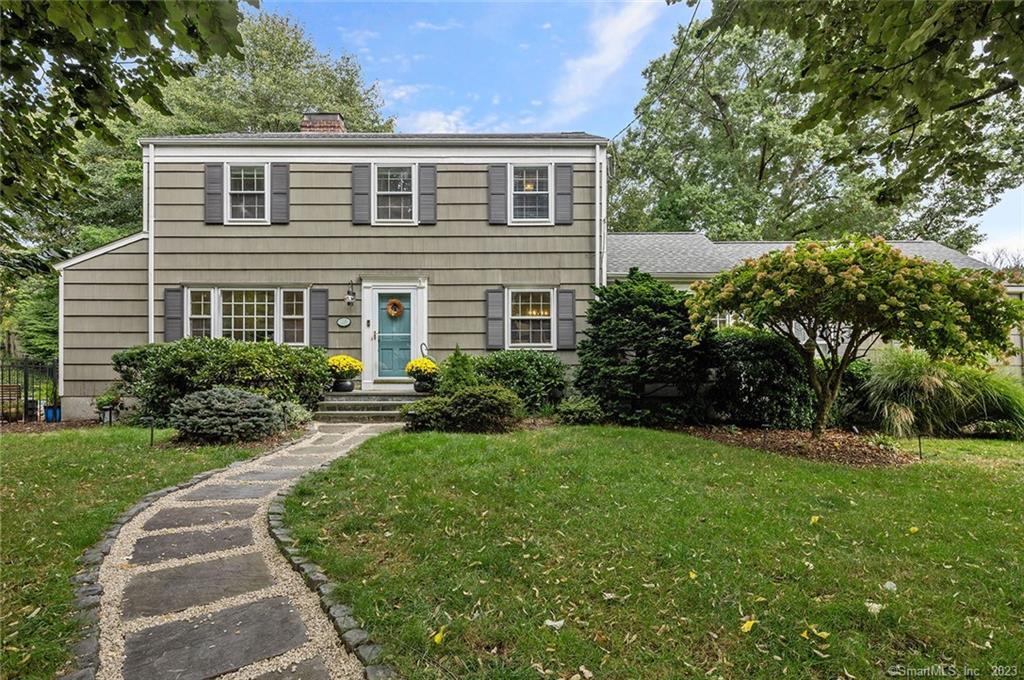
[124,554,273,619]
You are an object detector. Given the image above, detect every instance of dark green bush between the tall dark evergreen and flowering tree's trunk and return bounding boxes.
[703,327,814,429]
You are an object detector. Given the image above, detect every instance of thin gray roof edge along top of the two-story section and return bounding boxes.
[132,132,608,145]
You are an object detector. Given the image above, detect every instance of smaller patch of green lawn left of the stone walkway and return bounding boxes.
[0,427,280,678]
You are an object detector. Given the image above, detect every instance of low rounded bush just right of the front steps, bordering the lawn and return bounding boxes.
[402,385,525,432]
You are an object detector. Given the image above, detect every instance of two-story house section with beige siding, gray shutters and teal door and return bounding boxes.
[57,114,607,418]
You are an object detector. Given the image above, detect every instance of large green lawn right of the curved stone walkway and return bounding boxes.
[286,427,1024,680]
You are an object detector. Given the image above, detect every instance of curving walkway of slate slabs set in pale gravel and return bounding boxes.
[97,424,393,680]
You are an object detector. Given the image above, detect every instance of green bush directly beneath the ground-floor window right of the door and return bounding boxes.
[475,349,565,413]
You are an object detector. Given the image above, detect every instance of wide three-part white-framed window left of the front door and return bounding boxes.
[185,288,309,345]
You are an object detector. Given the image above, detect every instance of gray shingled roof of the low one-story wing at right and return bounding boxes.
[607,231,988,279]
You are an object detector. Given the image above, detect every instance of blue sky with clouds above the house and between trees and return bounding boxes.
[263,0,1024,251]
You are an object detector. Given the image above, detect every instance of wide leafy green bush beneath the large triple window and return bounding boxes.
[113,338,333,422]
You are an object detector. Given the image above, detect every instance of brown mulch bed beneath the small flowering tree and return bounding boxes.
[682,426,918,466]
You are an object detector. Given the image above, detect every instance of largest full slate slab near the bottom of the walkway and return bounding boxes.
[123,597,305,680]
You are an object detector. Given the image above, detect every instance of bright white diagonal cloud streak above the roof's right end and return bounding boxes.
[546,2,663,127]
